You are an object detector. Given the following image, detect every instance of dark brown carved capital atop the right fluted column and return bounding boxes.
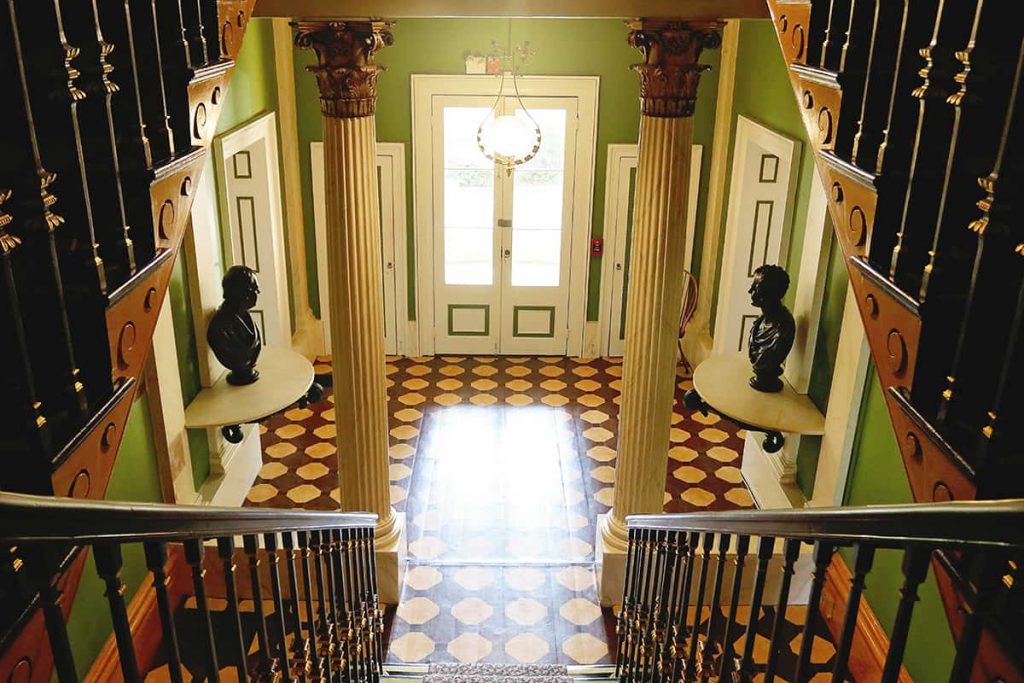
[628,19,725,118]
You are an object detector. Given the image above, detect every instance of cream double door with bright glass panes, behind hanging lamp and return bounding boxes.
[431,95,585,355]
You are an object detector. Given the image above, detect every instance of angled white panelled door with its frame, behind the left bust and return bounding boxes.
[214,112,292,348]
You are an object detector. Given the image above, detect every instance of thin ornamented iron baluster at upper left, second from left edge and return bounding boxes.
[7,0,89,415]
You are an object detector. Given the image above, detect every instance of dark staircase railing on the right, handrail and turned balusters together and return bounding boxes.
[616,500,1024,683]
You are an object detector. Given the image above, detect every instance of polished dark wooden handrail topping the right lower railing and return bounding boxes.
[626,499,1024,549]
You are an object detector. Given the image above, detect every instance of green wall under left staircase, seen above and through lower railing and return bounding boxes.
[68,393,163,678]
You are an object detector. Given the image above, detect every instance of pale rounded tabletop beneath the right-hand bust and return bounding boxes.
[693,353,825,434]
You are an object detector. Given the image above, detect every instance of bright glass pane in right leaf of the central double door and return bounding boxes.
[511,108,566,287]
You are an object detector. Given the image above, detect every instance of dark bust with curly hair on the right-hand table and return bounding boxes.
[748,264,797,391]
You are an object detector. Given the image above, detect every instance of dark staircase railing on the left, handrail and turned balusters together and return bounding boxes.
[0,494,384,683]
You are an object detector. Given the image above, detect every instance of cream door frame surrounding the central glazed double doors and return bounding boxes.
[411,74,600,355]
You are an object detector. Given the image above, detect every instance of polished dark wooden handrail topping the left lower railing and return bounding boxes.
[0,494,377,545]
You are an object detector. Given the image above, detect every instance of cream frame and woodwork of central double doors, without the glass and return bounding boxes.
[412,75,598,354]
